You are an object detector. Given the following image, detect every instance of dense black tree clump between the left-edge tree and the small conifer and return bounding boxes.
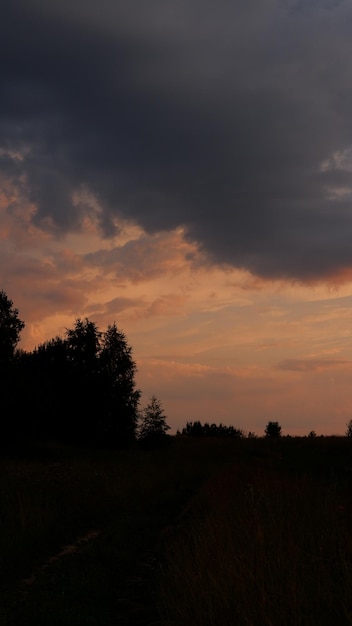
[8,318,140,447]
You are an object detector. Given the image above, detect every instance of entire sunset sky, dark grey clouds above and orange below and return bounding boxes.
[0,0,352,435]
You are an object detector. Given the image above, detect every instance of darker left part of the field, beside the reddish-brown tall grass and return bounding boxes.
[0,434,250,626]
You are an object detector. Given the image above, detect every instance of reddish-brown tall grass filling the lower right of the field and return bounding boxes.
[160,442,352,626]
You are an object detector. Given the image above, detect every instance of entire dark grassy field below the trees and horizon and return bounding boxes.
[0,437,352,626]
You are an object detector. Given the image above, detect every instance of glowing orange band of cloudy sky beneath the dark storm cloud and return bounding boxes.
[0,186,352,434]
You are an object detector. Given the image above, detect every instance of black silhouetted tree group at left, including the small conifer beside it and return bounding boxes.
[0,290,169,447]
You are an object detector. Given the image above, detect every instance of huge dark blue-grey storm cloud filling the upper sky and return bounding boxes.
[0,0,352,280]
